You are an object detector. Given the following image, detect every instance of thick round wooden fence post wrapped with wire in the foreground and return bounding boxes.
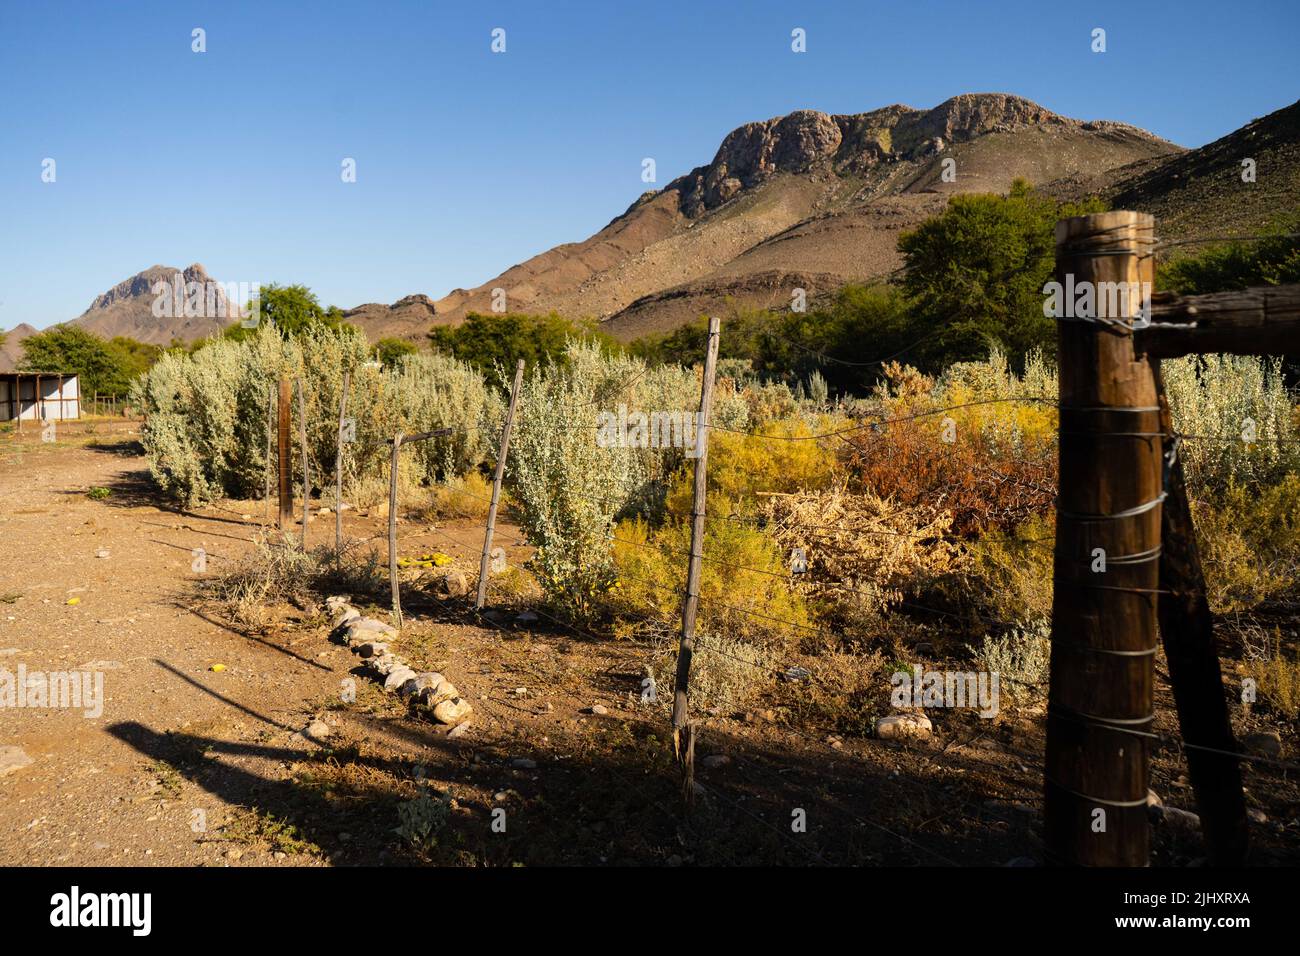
[1044,212,1164,866]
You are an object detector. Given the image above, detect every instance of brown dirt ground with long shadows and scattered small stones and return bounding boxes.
[0,421,1300,866]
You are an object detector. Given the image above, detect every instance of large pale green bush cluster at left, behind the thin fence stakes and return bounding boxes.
[131,325,502,505]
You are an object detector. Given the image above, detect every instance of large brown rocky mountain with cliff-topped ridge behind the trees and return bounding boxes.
[382,94,1183,339]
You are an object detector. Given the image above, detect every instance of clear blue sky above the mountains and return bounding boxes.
[0,0,1300,328]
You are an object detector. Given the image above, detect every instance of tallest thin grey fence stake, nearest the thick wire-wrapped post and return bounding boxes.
[672,317,719,803]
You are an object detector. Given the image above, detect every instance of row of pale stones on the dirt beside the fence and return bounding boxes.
[325,597,473,736]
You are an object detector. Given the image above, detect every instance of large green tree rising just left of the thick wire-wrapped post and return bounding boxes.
[898,179,1102,368]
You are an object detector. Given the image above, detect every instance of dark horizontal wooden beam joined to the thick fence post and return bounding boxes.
[1135,285,1300,359]
